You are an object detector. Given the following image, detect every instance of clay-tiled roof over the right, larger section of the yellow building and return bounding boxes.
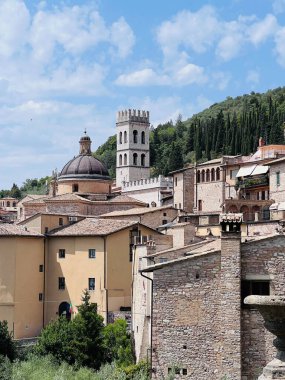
[48,218,140,236]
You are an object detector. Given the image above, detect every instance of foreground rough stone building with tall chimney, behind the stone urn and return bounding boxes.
[141,214,285,380]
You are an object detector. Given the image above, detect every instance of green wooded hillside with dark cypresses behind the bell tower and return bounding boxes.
[94,87,285,177]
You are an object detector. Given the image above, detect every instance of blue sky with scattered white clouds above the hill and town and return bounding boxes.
[0,0,285,189]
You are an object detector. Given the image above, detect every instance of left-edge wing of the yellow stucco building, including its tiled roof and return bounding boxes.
[0,224,44,339]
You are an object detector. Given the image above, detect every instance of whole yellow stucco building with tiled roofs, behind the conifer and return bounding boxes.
[0,214,163,339]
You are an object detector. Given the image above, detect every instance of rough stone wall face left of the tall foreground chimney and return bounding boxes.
[152,253,222,380]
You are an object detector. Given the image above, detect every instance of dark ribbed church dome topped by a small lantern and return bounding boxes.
[58,131,111,180]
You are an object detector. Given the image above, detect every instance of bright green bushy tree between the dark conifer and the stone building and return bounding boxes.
[104,319,134,367]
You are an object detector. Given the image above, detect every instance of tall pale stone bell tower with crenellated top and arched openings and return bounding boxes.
[116,109,150,186]
